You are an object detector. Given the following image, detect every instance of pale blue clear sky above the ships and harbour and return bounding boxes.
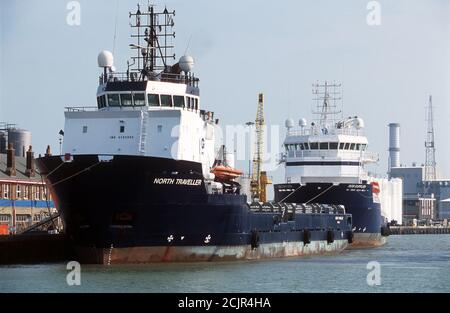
[0,0,450,179]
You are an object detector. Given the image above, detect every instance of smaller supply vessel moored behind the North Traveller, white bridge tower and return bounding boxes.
[274,82,397,247]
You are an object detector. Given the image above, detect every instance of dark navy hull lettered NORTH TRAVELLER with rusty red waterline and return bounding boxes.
[37,155,352,264]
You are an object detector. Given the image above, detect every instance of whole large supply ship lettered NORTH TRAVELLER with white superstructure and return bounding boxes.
[37,6,353,264]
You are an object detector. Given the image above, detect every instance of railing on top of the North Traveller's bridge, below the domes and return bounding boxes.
[99,71,200,87]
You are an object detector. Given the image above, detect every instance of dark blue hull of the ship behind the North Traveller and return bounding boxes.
[274,183,387,248]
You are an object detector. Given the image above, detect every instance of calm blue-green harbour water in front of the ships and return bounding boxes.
[0,235,450,293]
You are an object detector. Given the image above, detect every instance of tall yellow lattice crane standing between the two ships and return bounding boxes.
[250,93,272,202]
